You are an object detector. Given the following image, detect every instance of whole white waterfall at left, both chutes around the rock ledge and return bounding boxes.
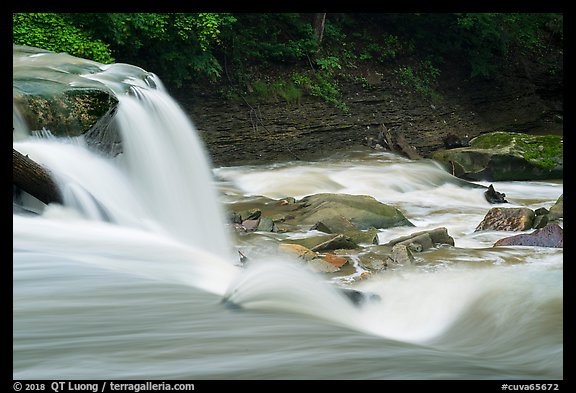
[14,59,233,260]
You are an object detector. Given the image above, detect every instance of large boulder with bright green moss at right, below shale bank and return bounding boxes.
[432,131,564,181]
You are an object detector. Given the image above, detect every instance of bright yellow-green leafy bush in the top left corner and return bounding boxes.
[12,13,114,64]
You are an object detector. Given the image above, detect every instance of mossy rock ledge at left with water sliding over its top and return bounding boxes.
[12,45,120,153]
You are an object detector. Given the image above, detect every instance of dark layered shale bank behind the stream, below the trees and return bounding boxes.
[174,57,563,166]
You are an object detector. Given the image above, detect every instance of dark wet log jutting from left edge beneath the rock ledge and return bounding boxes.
[12,149,62,204]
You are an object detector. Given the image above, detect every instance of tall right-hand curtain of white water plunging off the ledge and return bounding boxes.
[84,65,232,258]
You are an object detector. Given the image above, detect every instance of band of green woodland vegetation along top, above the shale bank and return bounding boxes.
[13,13,563,111]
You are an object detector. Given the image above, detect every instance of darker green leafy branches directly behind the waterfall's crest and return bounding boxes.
[70,13,236,86]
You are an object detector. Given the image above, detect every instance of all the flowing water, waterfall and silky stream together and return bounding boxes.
[13,53,563,380]
